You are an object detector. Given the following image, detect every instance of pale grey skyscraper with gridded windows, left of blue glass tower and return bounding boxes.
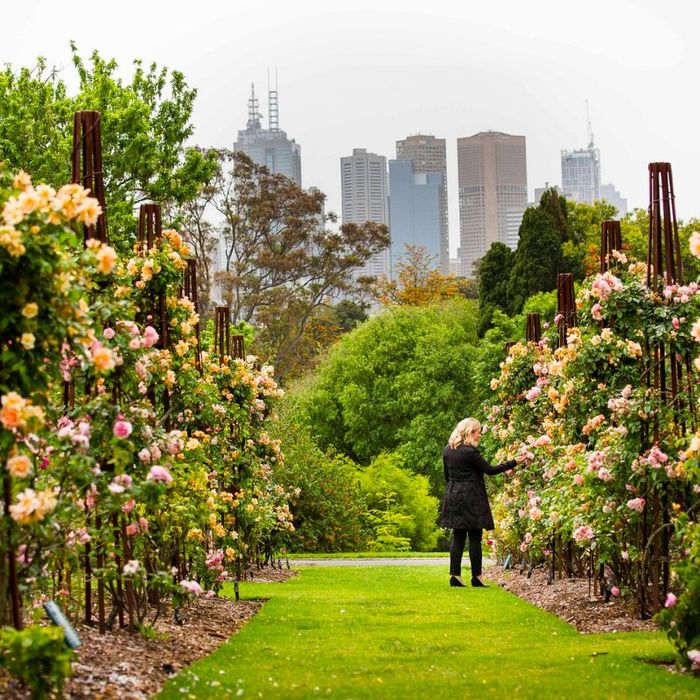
[340,148,391,277]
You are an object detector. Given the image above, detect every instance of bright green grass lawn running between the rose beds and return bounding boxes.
[156,566,700,700]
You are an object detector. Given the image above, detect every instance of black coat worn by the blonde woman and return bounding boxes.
[440,445,516,530]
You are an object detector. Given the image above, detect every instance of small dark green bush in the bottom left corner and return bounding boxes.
[0,625,74,700]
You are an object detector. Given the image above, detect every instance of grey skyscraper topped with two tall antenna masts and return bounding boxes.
[233,85,301,187]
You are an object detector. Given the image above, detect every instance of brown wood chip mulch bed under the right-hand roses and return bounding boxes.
[485,566,659,634]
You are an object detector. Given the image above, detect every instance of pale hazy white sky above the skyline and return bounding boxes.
[0,0,700,254]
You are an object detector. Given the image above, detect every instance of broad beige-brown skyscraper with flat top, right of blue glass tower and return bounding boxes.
[457,131,527,277]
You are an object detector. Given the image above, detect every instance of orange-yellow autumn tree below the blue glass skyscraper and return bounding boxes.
[375,244,474,306]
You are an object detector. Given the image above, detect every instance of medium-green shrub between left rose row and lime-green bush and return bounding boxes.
[270,397,366,552]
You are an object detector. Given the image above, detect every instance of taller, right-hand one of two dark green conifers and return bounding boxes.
[508,207,565,313]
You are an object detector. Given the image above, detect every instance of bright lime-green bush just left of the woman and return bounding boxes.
[357,454,440,552]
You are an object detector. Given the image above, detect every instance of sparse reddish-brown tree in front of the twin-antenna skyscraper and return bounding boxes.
[212,151,390,375]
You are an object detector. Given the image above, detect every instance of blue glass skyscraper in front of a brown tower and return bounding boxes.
[389,160,442,278]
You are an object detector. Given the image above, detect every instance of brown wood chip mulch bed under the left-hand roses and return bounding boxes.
[0,568,297,700]
